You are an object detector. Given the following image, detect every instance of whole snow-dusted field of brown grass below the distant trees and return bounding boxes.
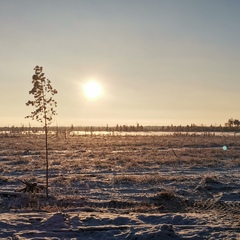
[0,134,240,240]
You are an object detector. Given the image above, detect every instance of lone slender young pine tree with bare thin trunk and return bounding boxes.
[26,66,57,198]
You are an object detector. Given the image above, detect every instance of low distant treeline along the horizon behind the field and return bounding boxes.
[0,118,240,133]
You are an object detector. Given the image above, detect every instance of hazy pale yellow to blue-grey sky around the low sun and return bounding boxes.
[0,0,240,126]
